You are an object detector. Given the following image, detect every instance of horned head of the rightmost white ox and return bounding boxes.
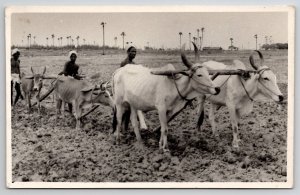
[249,50,283,102]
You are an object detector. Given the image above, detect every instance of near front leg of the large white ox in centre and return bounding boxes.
[158,109,169,152]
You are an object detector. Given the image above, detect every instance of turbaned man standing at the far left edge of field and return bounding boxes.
[10,48,23,105]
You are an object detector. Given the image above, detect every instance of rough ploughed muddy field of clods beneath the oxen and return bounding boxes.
[12,50,287,182]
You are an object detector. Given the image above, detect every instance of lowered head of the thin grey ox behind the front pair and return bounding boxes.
[81,82,113,107]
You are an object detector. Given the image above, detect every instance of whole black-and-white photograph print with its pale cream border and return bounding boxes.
[5,6,295,188]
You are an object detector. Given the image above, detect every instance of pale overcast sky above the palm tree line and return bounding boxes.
[11,12,288,49]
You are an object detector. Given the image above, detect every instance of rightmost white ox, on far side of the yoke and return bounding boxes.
[198,51,283,148]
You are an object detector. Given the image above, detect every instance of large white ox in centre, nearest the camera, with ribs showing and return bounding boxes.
[113,48,220,151]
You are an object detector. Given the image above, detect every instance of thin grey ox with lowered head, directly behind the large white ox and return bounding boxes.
[54,76,113,129]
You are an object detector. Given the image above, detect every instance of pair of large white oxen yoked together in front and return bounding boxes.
[112,47,283,151]
